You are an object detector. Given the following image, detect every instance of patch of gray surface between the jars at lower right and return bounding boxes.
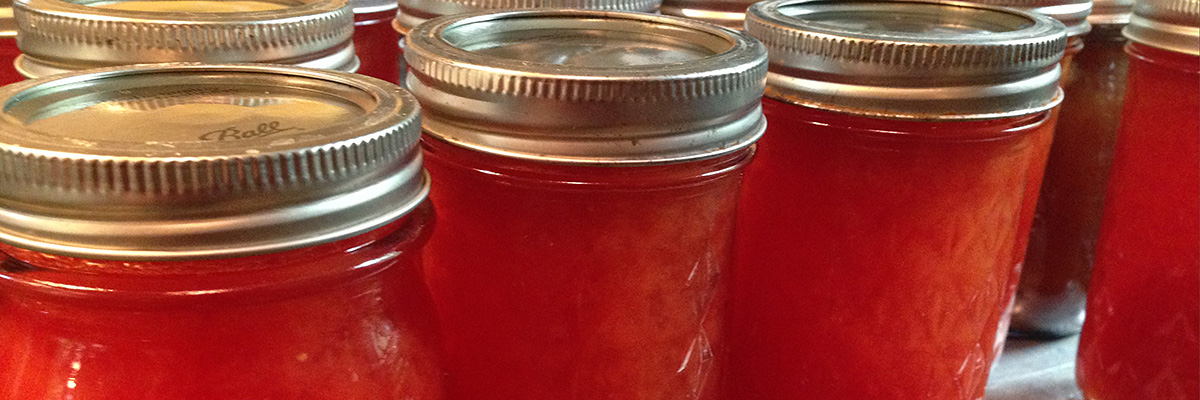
[986,336,1082,400]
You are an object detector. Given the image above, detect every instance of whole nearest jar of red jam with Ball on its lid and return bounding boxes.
[0,65,443,400]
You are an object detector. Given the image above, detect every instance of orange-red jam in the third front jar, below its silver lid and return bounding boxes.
[728,98,1052,400]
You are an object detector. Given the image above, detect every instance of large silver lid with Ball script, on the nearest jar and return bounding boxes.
[0,64,428,261]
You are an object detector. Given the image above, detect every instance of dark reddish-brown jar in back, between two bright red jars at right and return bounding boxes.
[1012,0,1133,338]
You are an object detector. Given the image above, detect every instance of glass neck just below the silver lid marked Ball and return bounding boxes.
[0,202,432,306]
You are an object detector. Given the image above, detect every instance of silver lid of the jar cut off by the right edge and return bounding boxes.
[1124,0,1200,55]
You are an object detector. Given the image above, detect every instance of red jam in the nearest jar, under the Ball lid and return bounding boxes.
[0,204,442,400]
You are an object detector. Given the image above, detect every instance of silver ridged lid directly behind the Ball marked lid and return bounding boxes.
[13,0,359,77]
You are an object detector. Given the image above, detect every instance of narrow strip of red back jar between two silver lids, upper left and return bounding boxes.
[350,0,403,84]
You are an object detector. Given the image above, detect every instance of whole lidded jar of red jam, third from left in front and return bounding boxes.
[725,0,1067,400]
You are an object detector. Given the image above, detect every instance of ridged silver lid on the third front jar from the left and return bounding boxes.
[746,0,1067,120]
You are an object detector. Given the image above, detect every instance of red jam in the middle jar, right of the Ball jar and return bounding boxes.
[424,138,751,399]
